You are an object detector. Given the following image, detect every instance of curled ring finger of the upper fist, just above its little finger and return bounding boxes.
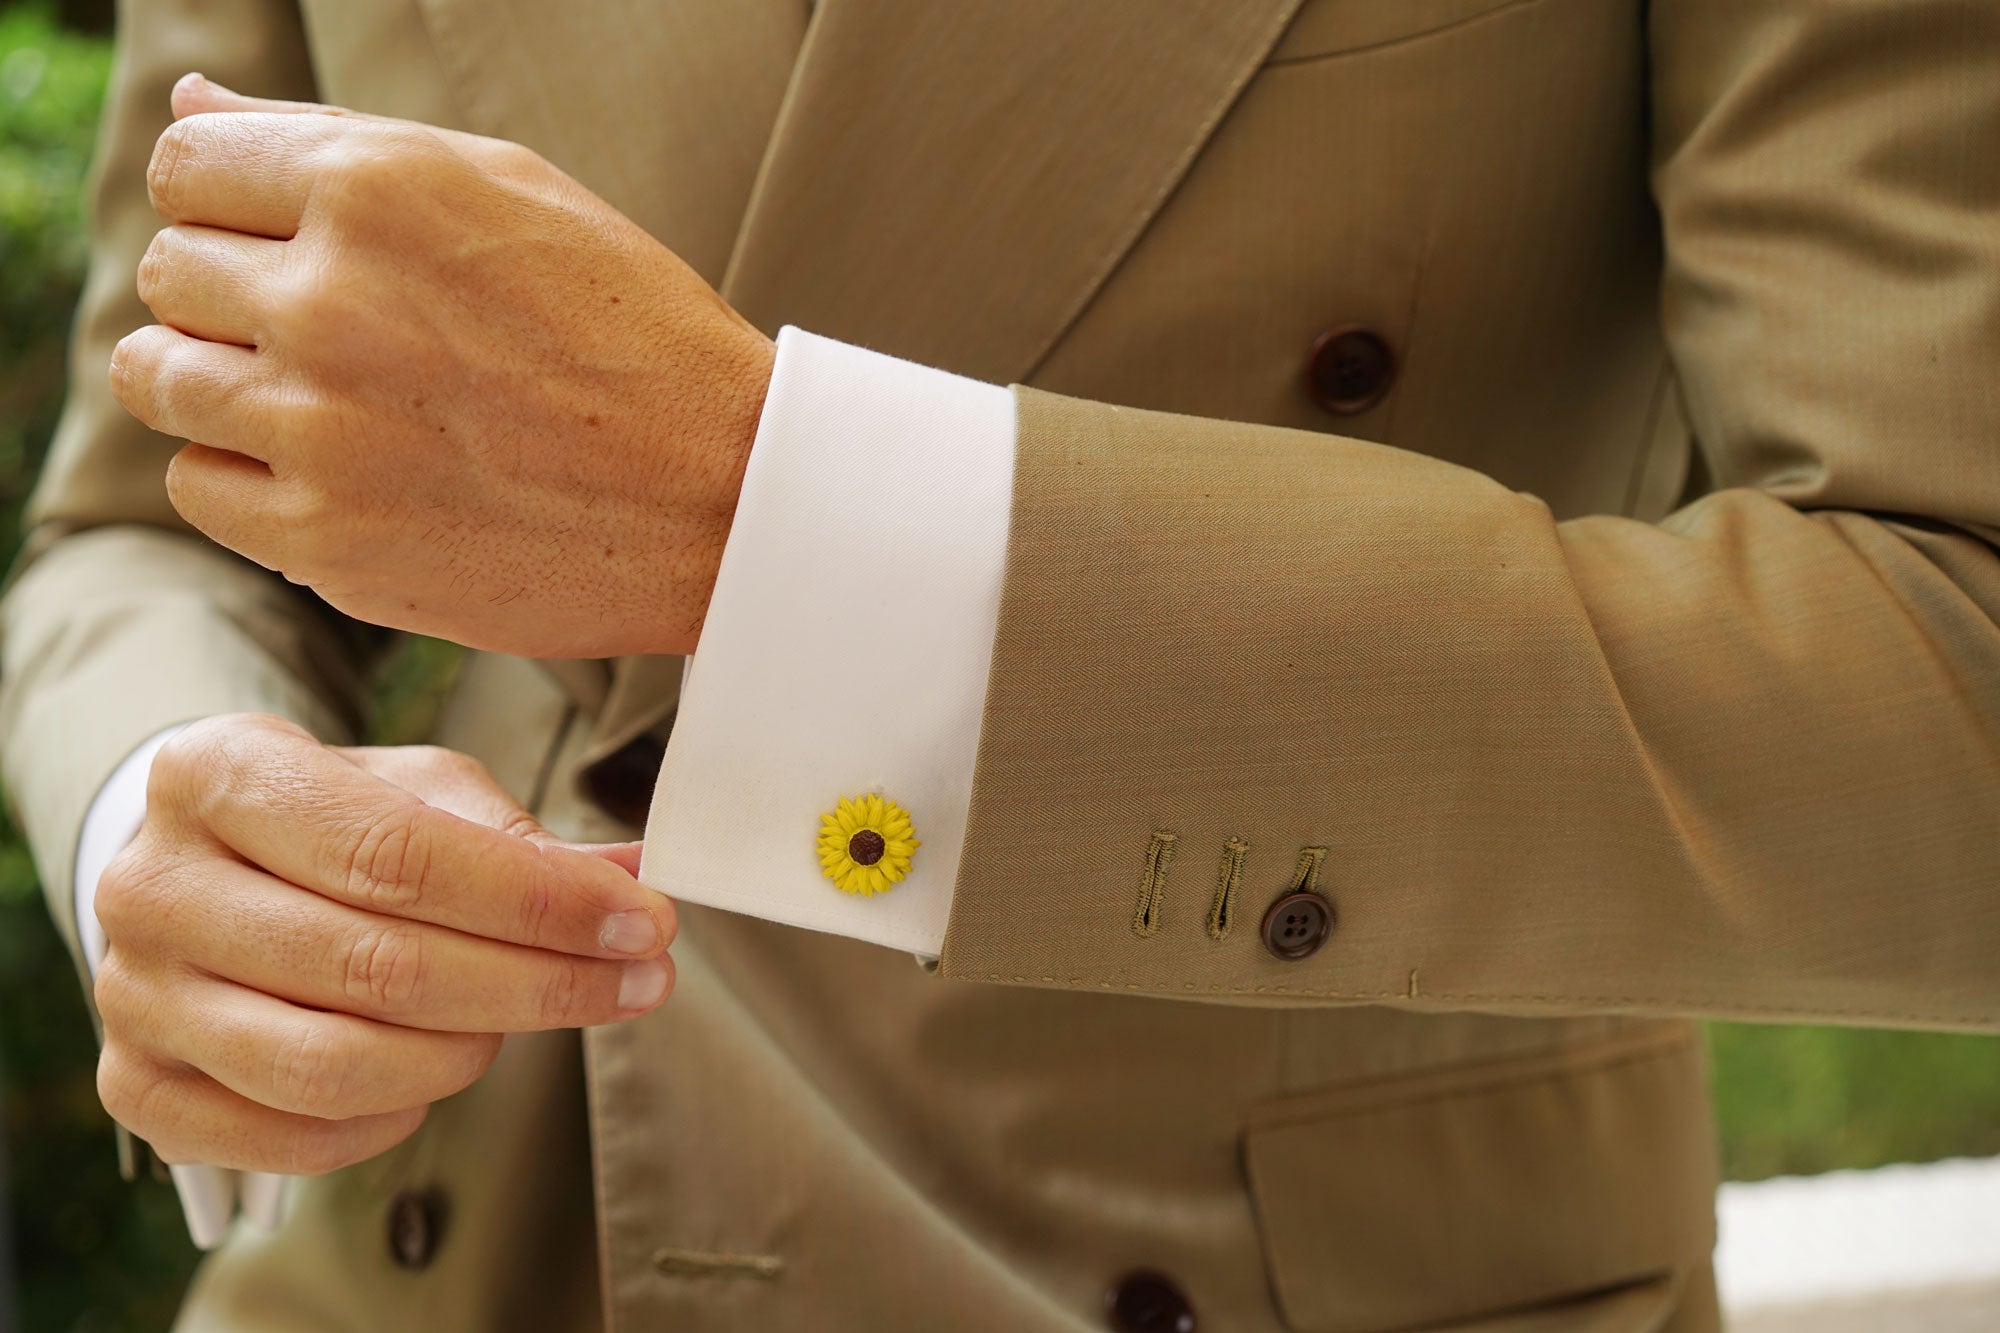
[110,324,274,458]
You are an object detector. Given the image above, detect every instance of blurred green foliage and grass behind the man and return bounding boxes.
[0,0,2000,1333]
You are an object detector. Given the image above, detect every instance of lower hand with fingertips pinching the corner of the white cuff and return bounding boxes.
[96,717,674,1175]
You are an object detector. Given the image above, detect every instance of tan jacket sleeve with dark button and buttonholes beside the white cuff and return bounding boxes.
[942,0,2000,1029]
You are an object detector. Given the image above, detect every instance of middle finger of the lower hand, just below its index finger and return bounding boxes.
[150,861,674,1033]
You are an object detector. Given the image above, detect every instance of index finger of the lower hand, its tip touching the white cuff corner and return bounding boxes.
[154,727,674,959]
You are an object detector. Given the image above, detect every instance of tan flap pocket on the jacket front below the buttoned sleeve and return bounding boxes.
[1244,1027,1714,1333]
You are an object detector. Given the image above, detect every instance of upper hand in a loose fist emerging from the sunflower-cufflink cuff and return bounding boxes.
[110,76,774,656]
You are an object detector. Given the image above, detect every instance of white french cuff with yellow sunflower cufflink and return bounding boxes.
[640,328,1014,957]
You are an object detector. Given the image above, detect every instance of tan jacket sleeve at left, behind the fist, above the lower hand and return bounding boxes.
[0,0,370,1012]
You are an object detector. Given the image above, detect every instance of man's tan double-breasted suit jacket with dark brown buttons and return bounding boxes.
[4,0,2000,1333]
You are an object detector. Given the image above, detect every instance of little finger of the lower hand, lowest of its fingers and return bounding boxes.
[98,1043,428,1175]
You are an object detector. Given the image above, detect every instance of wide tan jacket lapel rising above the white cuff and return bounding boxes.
[722,0,1300,382]
